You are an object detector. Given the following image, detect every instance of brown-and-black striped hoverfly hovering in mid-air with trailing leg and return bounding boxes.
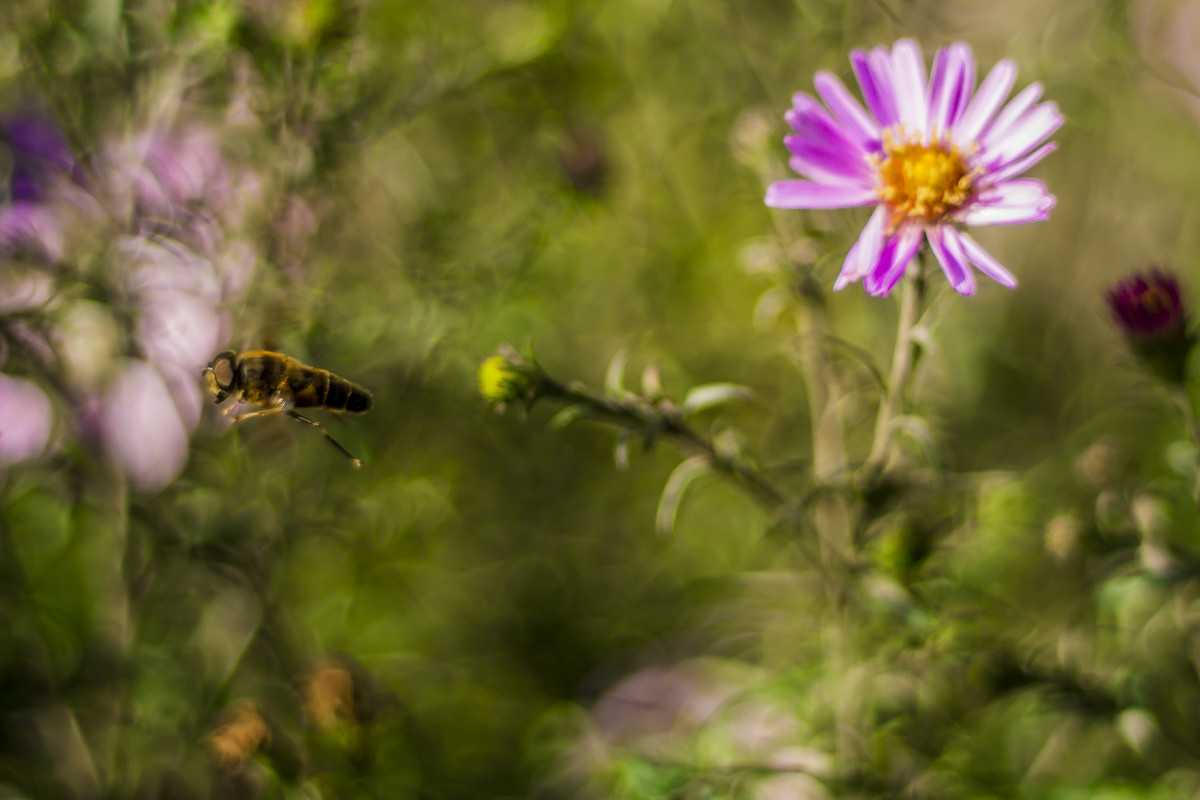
[202,350,373,467]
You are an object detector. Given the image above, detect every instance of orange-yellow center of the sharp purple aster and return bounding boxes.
[871,131,978,225]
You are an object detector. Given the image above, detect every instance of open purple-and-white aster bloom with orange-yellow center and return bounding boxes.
[767,38,1062,295]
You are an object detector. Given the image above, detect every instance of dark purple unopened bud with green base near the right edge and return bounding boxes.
[1106,267,1195,383]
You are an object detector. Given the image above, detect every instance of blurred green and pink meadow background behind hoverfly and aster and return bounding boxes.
[7,0,1200,800]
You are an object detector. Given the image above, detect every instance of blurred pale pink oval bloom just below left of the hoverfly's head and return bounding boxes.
[100,360,187,491]
